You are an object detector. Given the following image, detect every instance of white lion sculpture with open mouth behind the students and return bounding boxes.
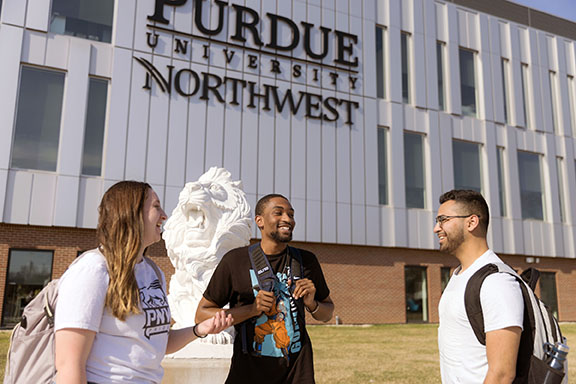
[162,167,252,344]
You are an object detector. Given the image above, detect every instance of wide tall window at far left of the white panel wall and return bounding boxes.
[12,66,65,171]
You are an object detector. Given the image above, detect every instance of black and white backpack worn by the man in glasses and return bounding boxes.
[464,263,568,384]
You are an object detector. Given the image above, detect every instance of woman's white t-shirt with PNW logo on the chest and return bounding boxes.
[55,249,170,384]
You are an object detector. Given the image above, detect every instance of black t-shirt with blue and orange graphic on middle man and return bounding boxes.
[204,247,330,384]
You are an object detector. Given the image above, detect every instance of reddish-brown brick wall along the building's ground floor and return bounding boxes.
[0,224,576,324]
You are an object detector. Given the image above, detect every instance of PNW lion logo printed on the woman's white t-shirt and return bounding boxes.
[138,279,170,339]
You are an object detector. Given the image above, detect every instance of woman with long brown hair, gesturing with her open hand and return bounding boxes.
[55,181,232,384]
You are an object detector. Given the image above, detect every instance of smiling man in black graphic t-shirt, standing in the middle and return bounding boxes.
[196,194,334,384]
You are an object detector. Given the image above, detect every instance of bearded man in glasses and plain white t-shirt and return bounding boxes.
[434,190,524,384]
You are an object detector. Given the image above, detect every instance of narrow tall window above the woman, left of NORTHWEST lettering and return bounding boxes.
[82,78,108,176]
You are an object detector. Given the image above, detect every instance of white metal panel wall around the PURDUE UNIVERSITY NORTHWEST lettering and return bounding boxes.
[0,0,576,256]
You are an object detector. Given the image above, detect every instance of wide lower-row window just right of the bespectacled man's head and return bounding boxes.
[518,151,544,220]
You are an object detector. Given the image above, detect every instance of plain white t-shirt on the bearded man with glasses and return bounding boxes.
[438,250,524,384]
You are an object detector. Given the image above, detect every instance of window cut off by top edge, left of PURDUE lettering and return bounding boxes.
[50,0,114,43]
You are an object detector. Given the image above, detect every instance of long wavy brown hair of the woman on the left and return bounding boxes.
[97,181,152,321]
